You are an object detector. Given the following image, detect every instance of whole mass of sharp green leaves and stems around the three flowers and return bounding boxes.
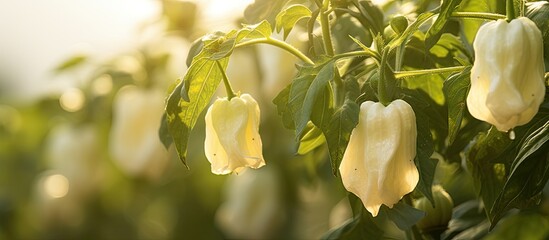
[163,0,549,236]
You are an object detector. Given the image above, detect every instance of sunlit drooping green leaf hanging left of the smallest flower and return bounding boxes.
[166,51,228,166]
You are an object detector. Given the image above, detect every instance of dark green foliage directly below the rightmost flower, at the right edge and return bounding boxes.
[468,107,549,226]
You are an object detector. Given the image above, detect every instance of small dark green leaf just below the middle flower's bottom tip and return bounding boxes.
[380,201,425,231]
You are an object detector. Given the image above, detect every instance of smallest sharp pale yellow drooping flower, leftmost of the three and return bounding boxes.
[204,94,265,174]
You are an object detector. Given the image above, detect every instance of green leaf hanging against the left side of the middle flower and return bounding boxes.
[322,99,360,176]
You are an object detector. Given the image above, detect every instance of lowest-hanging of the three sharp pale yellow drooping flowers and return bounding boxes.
[339,100,419,217]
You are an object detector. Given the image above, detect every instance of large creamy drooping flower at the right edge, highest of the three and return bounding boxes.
[467,17,545,132]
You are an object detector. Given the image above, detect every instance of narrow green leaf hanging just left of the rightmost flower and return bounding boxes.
[443,68,471,145]
